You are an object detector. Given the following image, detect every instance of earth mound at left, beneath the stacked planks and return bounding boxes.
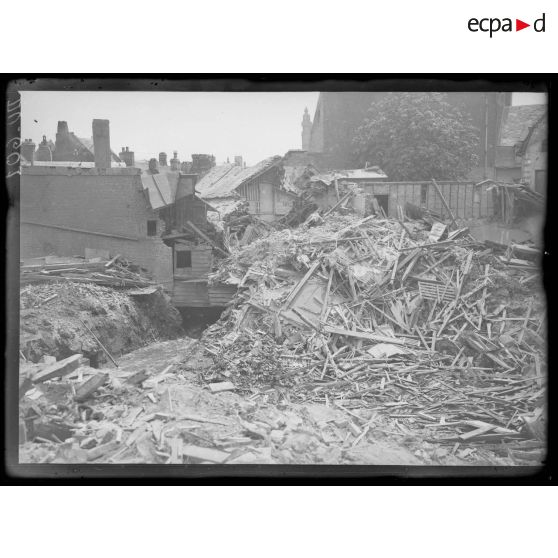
[20,282,183,365]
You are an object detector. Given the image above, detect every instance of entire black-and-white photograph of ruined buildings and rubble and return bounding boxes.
[7,82,549,468]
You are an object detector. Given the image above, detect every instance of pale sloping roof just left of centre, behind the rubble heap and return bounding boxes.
[196,155,282,199]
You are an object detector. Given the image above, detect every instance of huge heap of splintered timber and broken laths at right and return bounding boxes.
[202,214,546,463]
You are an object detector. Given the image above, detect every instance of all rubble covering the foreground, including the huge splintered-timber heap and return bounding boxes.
[20,213,546,465]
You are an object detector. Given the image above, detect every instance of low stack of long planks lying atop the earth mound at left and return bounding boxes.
[20,256,154,288]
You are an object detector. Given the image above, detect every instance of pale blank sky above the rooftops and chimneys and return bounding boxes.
[21,91,545,165]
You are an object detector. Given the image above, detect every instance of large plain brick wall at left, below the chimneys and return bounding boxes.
[20,167,172,285]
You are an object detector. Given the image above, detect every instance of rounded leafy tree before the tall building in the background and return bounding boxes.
[353,93,479,180]
